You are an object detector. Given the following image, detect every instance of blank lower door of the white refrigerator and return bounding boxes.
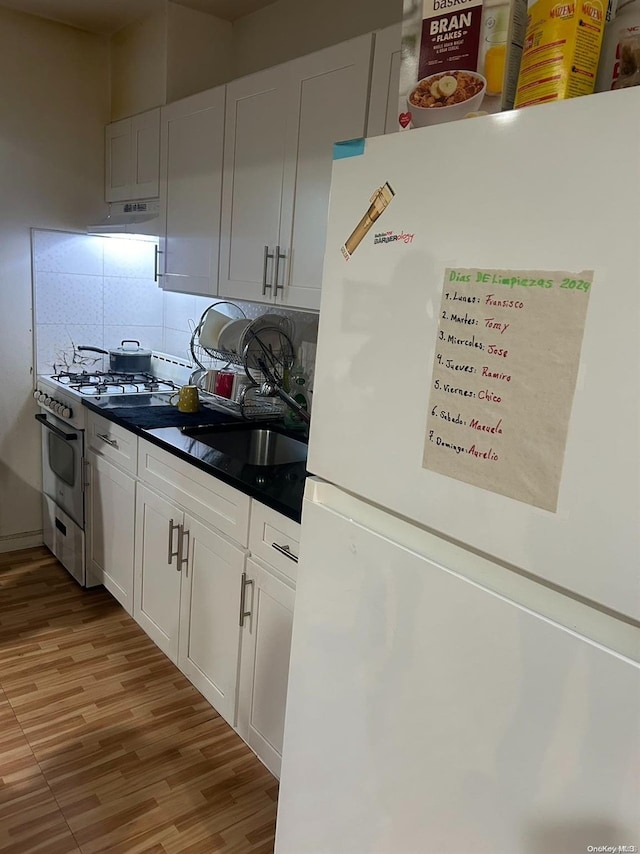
[276,484,640,854]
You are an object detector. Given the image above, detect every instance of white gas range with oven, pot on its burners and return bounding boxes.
[33,354,192,587]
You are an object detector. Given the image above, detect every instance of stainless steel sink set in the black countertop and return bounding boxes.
[182,425,307,466]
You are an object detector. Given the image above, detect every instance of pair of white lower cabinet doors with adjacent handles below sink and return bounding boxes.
[134,484,246,726]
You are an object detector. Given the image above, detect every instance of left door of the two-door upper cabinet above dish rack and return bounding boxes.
[219,63,290,302]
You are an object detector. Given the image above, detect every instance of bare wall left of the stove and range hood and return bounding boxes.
[0,8,109,551]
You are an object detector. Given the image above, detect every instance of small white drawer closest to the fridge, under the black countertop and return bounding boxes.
[249,500,300,582]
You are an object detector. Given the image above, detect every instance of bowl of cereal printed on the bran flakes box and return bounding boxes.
[407,70,487,127]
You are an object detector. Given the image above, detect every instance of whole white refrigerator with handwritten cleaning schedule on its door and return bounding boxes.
[276,88,640,854]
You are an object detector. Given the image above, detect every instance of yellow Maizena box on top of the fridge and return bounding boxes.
[515,0,607,108]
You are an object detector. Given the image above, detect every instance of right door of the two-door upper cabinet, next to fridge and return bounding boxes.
[277,35,372,309]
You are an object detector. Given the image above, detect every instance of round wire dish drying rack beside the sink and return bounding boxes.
[189,300,295,421]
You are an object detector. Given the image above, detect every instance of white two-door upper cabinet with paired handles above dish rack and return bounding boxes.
[219,35,372,309]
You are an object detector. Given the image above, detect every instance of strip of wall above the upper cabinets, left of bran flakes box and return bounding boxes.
[232,0,402,78]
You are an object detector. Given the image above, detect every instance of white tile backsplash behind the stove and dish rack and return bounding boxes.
[31,229,318,382]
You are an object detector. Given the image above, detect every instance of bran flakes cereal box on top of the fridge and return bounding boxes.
[398,0,527,130]
